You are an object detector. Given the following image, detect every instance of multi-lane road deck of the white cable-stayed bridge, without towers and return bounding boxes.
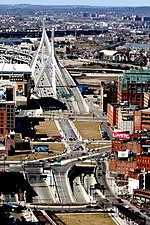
[35,57,88,113]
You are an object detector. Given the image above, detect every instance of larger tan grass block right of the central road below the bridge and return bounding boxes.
[73,120,102,140]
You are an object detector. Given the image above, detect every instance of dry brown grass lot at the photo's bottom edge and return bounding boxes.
[57,214,116,225]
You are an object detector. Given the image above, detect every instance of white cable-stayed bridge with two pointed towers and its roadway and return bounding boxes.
[32,24,89,113]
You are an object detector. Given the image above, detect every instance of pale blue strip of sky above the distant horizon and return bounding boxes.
[0,0,150,6]
